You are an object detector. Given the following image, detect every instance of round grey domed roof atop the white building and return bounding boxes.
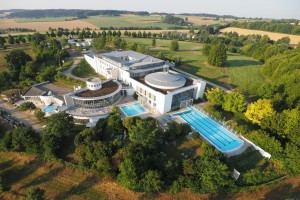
[145,72,186,89]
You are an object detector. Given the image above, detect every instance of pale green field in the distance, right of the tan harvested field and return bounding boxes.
[83,15,180,29]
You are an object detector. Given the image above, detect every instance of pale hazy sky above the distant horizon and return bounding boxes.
[0,0,300,19]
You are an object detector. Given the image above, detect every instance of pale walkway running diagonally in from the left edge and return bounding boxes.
[0,100,43,132]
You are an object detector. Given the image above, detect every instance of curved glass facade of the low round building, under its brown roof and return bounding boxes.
[73,92,121,109]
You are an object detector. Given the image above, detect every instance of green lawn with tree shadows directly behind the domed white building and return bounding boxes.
[126,38,264,92]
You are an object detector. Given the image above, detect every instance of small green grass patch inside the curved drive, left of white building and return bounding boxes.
[72,60,105,80]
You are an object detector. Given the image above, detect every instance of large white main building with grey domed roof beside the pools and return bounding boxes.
[85,51,206,114]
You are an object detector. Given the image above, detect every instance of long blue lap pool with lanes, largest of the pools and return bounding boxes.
[172,108,244,153]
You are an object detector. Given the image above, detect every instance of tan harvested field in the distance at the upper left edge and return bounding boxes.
[0,19,98,31]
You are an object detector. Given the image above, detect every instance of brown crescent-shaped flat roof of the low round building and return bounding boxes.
[75,80,119,97]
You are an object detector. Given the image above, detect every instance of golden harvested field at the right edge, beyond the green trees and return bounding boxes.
[220,27,300,45]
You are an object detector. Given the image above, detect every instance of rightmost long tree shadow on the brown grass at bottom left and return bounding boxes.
[55,176,100,199]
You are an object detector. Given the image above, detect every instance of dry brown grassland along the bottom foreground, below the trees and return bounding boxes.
[0,152,300,200]
